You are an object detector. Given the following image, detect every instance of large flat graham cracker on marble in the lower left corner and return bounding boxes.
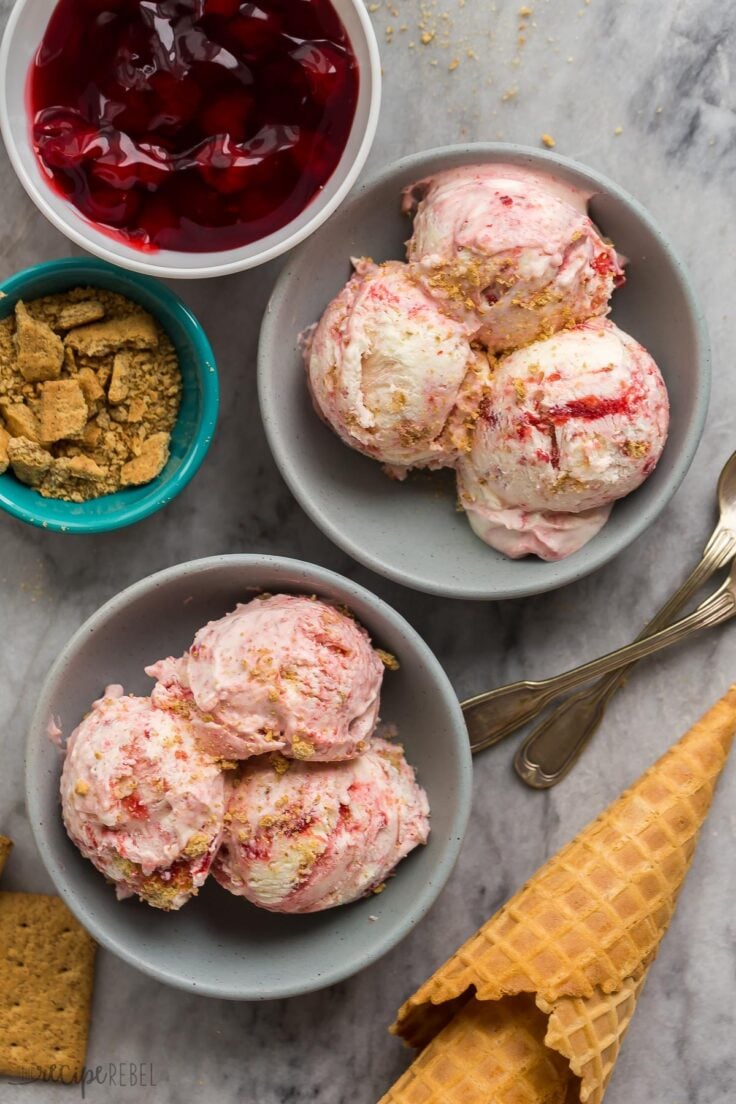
[0,892,96,1083]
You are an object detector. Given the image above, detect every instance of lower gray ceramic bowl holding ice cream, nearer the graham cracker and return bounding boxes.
[25,555,471,1000]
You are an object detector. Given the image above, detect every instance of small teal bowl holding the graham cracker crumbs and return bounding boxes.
[0,257,220,533]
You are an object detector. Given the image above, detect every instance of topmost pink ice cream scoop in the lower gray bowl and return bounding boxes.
[146,594,384,761]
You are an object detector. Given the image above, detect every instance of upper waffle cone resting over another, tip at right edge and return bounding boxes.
[385,687,736,1104]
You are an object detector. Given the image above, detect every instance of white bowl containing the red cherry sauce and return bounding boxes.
[0,0,381,279]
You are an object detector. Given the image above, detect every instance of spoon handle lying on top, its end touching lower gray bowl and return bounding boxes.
[463,580,736,752]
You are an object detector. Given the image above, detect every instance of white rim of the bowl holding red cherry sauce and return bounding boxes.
[0,0,383,279]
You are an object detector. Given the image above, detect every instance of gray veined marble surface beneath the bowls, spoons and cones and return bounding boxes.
[0,0,736,1104]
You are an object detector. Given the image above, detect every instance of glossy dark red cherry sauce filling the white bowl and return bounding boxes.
[29,0,359,252]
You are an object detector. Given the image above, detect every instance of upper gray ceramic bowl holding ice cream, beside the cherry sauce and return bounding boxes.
[258,145,711,598]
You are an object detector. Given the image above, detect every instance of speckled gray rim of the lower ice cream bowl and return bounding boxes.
[25,554,472,1000]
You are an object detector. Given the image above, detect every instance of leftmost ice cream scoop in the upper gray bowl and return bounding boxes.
[305,261,488,477]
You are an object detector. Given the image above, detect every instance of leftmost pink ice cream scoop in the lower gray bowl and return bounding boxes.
[61,686,227,910]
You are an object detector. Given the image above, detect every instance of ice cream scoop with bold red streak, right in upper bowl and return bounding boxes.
[458,318,669,560]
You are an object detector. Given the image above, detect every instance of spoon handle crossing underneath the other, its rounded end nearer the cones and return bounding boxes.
[514,526,736,789]
